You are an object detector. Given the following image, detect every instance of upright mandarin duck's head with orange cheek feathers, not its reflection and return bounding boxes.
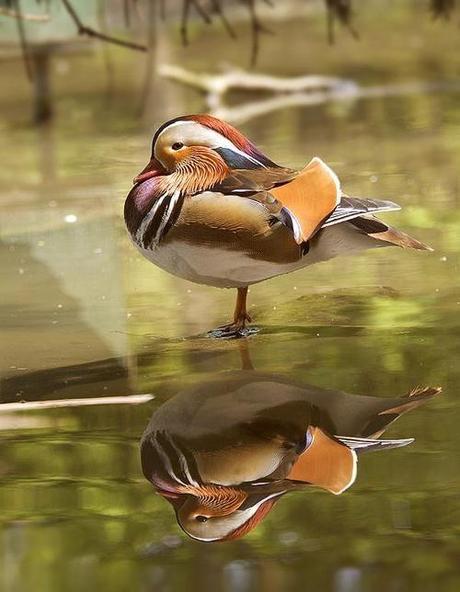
[134,115,276,191]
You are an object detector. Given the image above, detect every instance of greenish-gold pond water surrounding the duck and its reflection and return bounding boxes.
[0,4,460,592]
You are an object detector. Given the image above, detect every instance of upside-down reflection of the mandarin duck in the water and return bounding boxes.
[141,370,441,542]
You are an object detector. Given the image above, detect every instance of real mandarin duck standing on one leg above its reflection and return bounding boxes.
[125,115,430,337]
